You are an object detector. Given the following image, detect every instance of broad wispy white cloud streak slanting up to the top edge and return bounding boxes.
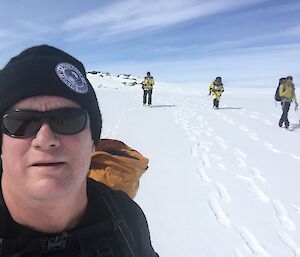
[63,0,265,40]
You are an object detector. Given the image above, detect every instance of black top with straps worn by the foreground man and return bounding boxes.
[0,179,158,257]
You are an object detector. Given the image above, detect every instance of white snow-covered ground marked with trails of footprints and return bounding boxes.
[89,74,300,257]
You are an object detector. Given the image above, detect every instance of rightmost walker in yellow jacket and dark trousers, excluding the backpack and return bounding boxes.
[278,76,298,129]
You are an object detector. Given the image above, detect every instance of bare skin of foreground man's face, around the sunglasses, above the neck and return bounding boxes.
[2,96,94,201]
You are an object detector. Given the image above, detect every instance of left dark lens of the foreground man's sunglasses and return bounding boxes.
[3,111,41,137]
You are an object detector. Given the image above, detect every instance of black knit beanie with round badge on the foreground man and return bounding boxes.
[0,45,102,145]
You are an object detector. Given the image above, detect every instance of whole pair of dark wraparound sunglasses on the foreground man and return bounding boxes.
[2,108,89,138]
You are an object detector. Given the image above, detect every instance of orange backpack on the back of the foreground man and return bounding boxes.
[88,139,149,198]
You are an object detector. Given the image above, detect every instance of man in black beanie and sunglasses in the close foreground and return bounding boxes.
[0,45,158,257]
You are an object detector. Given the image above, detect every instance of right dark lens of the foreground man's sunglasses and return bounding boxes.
[49,108,88,135]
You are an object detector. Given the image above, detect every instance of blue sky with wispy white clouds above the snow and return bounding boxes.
[0,0,300,86]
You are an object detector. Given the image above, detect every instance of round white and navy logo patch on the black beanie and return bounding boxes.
[55,63,88,94]
